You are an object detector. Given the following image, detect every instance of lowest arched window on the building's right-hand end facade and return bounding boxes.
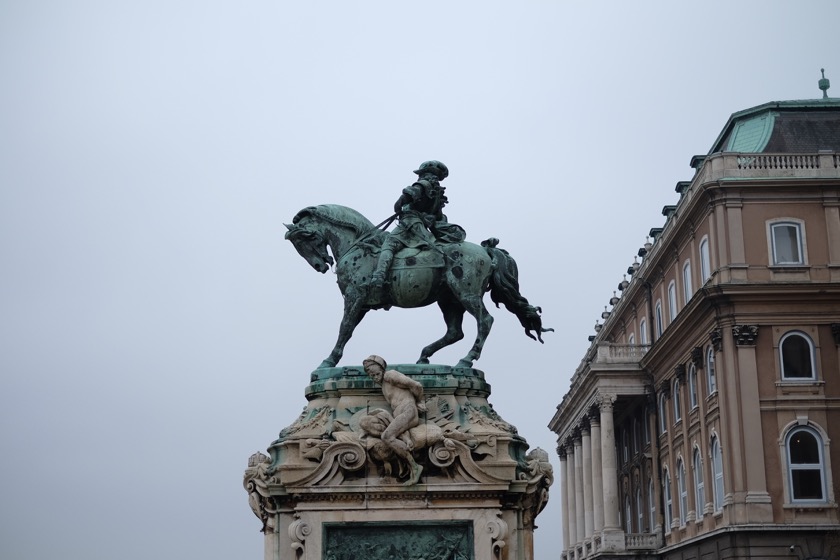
[785,426,826,502]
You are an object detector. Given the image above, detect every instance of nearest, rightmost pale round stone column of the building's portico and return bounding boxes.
[598,394,625,551]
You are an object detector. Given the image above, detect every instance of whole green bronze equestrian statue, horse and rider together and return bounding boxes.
[286,161,552,368]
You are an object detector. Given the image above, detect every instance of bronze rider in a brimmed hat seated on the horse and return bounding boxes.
[371,160,466,299]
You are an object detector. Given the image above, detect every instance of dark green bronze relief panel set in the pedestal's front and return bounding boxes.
[323,521,475,560]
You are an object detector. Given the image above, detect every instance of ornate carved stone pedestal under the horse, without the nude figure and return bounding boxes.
[244,364,553,560]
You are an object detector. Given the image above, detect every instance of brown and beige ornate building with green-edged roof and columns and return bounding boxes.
[549,80,840,560]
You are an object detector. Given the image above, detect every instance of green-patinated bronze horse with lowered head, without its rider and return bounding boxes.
[286,204,553,368]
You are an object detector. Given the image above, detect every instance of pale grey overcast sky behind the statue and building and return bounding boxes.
[0,0,840,560]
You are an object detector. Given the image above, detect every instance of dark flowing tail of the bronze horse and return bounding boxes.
[481,238,554,343]
